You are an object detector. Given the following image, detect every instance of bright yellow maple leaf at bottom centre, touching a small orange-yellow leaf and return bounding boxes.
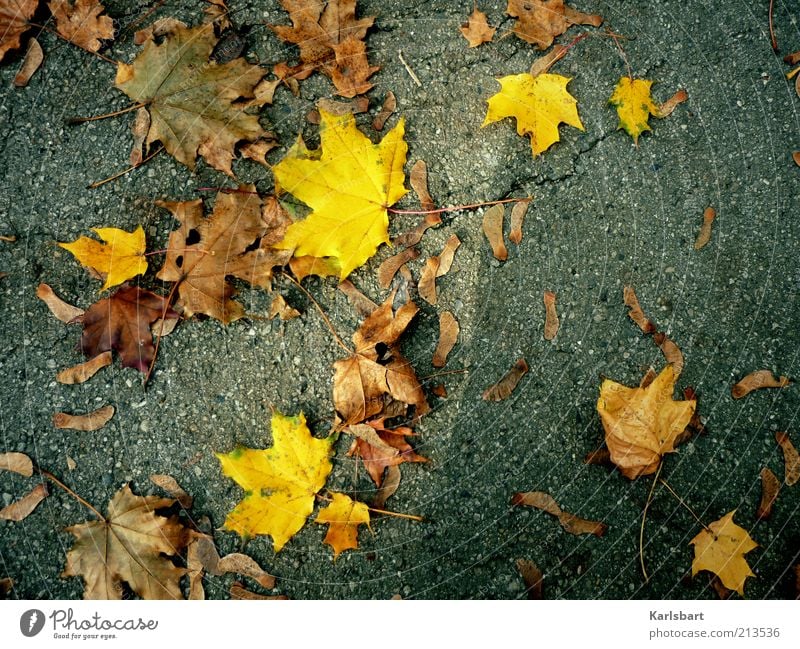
[216,412,335,552]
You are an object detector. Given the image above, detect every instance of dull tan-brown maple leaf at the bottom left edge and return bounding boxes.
[62,485,189,599]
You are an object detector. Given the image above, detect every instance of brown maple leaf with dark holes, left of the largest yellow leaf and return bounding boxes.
[157,185,291,324]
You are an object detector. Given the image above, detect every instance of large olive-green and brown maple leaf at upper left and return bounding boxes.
[116,24,265,176]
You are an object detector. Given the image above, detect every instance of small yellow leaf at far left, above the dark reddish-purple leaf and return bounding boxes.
[58,225,147,291]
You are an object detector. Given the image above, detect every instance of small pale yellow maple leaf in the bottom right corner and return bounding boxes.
[689,509,758,597]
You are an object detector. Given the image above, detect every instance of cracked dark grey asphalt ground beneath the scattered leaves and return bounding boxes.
[0,0,800,599]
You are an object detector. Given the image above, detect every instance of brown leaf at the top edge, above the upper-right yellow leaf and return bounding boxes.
[506,0,603,50]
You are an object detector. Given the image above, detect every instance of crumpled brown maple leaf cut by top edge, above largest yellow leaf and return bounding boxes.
[270,0,379,97]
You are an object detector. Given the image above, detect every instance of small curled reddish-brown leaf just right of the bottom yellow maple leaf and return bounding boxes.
[347,417,428,487]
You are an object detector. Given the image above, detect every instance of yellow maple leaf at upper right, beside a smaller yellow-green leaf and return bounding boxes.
[481,72,584,155]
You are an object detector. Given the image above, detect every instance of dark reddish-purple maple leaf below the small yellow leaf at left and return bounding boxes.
[81,284,179,373]
